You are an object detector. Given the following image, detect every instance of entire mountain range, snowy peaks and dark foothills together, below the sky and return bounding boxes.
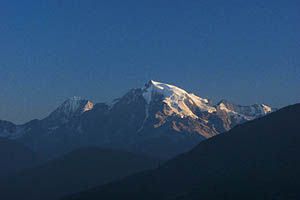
[0,81,300,200]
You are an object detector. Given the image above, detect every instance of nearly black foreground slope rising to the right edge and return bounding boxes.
[64,104,300,200]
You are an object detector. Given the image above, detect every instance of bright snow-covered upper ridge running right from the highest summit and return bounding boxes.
[143,80,273,120]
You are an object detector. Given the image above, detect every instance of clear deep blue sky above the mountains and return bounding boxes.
[0,0,300,123]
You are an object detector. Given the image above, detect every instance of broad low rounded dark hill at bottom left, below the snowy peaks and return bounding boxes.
[0,148,158,200]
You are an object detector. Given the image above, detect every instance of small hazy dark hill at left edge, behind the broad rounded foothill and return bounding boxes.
[0,138,40,176]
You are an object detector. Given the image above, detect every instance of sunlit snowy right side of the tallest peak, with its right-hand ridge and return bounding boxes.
[130,80,274,138]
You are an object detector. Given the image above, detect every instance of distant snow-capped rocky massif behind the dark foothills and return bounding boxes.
[0,80,274,158]
